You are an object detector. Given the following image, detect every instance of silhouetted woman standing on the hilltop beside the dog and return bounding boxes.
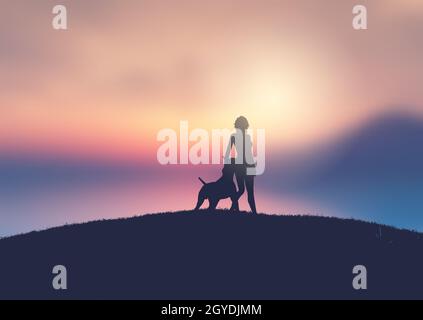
[225,116,257,214]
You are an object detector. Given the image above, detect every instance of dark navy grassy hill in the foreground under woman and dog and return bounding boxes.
[0,211,423,299]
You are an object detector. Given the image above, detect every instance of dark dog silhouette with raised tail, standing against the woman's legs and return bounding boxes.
[194,159,239,211]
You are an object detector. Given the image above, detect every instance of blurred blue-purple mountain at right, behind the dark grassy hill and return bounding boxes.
[266,112,423,231]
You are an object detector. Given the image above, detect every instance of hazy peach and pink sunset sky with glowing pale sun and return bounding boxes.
[0,0,423,232]
